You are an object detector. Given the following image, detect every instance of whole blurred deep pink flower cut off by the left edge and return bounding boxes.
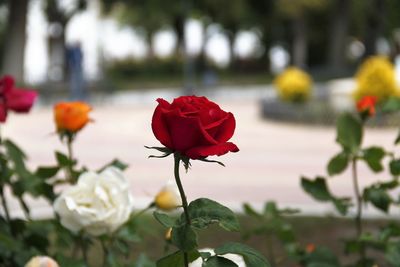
[0,75,37,122]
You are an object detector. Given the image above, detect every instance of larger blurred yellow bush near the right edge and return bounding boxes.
[353,56,398,102]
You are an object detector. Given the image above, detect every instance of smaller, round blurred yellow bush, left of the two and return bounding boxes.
[274,67,313,102]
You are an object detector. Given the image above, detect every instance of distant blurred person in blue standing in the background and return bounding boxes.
[66,42,87,100]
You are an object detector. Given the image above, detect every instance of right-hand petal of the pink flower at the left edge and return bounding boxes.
[6,89,37,112]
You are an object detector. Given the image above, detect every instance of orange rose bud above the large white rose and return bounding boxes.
[54,101,92,133]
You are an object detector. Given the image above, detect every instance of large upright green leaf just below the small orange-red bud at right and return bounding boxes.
[336,113,363,154]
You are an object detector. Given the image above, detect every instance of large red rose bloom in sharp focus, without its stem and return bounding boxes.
[151,96,239,159]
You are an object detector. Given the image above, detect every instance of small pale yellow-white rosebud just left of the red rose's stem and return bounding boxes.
[154,180,182,211]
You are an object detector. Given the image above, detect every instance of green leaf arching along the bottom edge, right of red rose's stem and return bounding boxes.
[215,242,271,267]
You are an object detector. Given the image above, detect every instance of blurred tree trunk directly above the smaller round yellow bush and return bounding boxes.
[292,15,307,68]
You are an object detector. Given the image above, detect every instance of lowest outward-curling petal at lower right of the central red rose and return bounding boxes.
[185,142,239,159]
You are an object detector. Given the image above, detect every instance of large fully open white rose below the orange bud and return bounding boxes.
[54,167,133,236]
